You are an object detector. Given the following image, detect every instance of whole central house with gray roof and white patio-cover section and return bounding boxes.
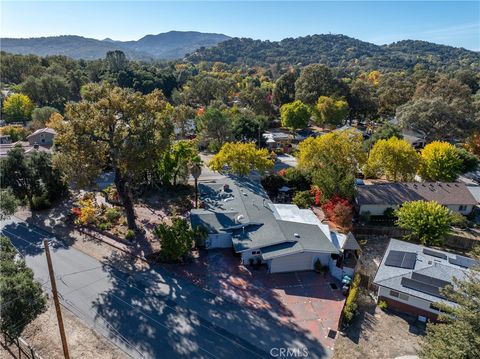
[191,177,359,278]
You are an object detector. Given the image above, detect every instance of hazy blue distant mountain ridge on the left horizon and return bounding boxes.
[0,31,230,60]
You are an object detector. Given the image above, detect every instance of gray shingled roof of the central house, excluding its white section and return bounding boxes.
[191,176,338,258]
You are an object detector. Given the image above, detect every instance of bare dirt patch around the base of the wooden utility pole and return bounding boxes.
[6,300,127,359]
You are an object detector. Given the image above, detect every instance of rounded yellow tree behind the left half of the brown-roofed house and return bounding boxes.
[364,137,420,181]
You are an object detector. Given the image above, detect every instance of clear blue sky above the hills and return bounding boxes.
[0,0,480,51]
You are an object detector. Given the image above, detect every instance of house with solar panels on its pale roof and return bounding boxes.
[373,239,479,320]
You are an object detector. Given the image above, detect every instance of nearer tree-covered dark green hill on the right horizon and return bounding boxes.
[186,34,480,70]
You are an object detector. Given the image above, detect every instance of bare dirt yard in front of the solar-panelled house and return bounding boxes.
[333,291,425,359]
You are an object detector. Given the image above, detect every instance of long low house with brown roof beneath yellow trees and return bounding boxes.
[355,182,477,216]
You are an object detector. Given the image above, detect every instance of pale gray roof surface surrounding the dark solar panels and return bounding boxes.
[373,239,473,305]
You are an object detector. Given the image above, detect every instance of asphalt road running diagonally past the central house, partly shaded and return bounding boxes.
[0,219,331,359]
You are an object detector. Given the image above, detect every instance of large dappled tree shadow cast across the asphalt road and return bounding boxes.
[93,254,331,358]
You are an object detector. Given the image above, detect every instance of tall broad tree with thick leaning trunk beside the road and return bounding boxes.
[55,84,173,230]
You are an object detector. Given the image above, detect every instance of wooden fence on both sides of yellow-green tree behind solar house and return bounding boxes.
[352,225,480,251]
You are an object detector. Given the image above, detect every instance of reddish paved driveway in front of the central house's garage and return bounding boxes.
[169,249,345,349]
